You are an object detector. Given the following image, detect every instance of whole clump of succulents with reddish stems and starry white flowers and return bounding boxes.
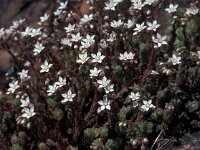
[0,0,200,150]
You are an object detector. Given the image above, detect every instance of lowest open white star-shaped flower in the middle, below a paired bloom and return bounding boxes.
[97,95,111,113]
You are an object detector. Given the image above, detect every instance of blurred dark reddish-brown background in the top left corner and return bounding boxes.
[0,0,56,27]
